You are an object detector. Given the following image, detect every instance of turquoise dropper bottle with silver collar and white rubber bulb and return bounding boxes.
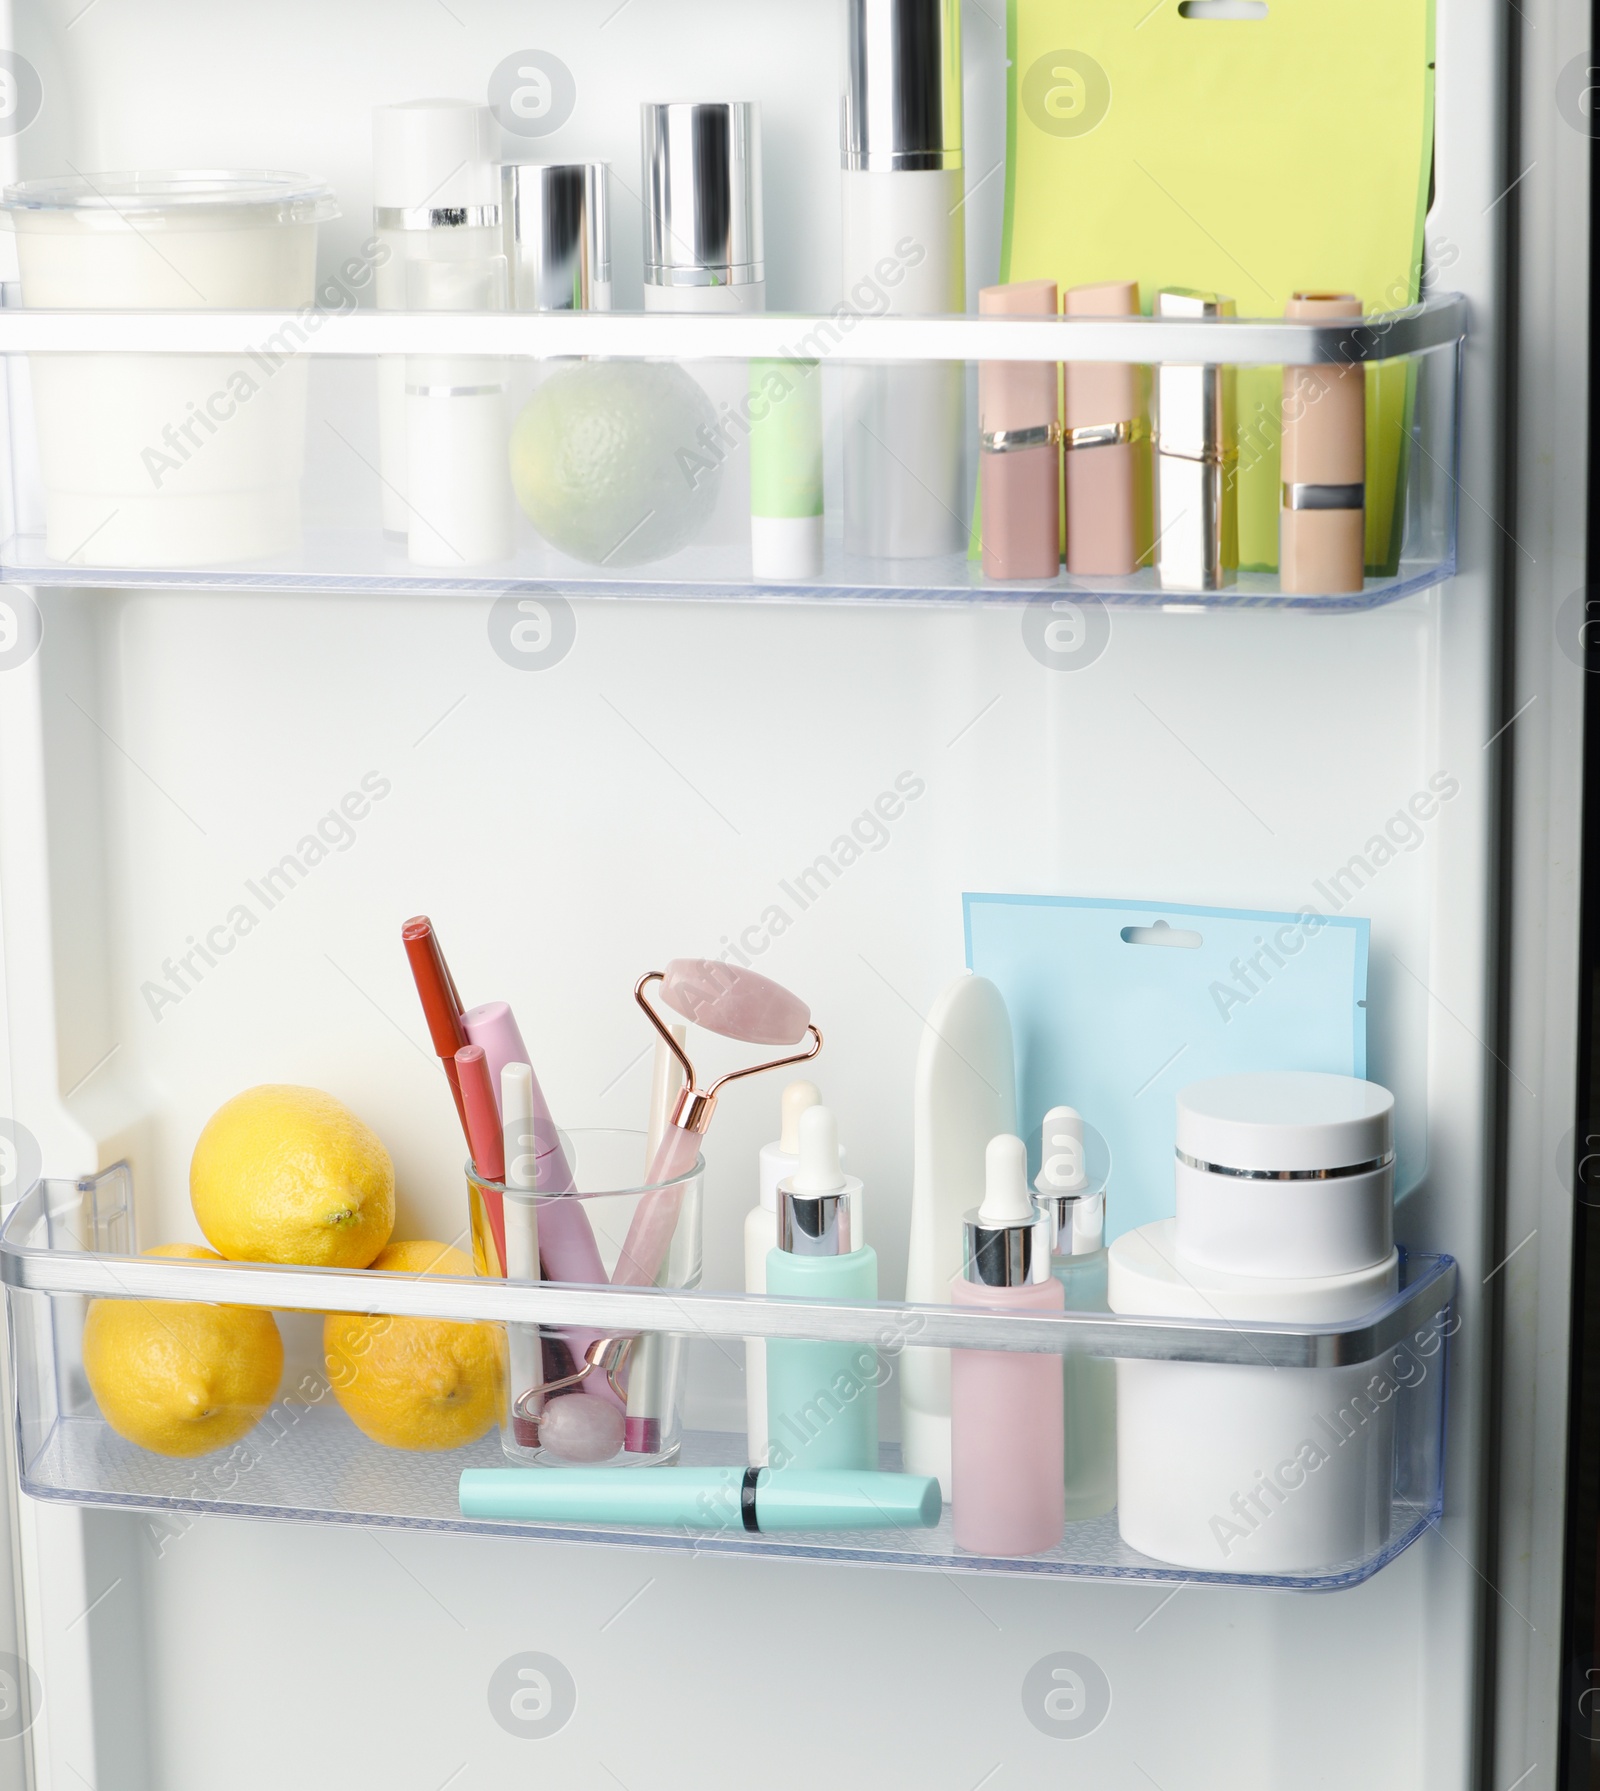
[767,1107,881,1470]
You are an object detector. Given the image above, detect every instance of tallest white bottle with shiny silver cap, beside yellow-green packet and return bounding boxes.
[840,0,966,559]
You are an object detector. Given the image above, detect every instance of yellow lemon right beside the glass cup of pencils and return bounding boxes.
[323,1241,500,1449]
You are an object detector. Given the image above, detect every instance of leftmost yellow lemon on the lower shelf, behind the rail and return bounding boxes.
[84,1243,283,1456]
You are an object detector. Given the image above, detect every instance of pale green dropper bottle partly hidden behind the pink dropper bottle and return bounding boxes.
[1034,1107,1116,1524]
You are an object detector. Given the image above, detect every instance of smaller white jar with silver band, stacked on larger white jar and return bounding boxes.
[1177,1069,1394,1277]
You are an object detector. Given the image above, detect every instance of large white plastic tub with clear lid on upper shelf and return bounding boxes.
[0,172,339,566]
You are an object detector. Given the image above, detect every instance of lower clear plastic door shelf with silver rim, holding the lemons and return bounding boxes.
[0,1166,1455,1590]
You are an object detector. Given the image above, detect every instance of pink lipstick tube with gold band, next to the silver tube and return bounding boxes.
[1061,279,1150,578]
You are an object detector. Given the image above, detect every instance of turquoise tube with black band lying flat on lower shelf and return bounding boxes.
[457,1467,941,1533]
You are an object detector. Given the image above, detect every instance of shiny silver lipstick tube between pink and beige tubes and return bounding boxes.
[1156,287,1238,591]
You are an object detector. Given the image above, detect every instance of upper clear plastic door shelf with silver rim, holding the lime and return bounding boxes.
[0,294,1467,611]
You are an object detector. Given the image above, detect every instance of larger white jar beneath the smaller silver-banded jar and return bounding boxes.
[1107,1220,1399,1574]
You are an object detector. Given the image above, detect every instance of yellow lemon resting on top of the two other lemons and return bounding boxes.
[188,1084,394,1268]
